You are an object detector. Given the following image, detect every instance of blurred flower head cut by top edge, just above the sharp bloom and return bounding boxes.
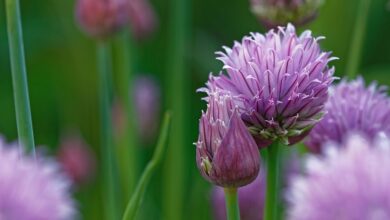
[251,0,323,28]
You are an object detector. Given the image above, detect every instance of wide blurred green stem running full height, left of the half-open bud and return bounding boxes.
[163,0,191,220]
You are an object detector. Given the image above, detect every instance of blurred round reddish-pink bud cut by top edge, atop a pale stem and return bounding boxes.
[76,0,129,38]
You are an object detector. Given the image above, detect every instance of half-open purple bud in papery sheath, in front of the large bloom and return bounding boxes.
[196,90,260,187]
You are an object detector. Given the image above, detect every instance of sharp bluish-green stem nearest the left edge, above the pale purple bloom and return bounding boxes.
[6,0,35,156]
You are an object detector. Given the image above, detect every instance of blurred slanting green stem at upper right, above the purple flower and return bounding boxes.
[346,0,371,78]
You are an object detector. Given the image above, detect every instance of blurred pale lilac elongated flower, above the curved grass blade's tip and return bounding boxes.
[133,76,161,142]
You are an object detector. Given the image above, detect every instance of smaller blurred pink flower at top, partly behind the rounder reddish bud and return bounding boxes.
[128,0,157,39]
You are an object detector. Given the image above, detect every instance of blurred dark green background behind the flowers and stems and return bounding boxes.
[0,0,390,219]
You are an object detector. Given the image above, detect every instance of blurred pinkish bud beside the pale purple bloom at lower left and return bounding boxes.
[57,135,96,184]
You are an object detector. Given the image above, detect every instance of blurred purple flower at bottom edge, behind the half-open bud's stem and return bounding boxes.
[212,169,266,220]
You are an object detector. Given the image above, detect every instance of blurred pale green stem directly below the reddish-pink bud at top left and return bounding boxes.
[98,41,119,220]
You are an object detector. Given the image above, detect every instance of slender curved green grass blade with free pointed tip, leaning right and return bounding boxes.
[122,113,171,220]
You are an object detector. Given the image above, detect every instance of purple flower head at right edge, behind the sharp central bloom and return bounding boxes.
[306,77,390,153]
